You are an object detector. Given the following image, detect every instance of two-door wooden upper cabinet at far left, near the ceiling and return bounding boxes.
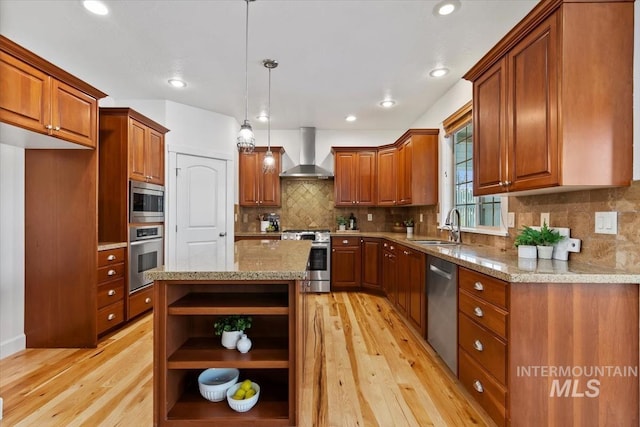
[0,36,106,148]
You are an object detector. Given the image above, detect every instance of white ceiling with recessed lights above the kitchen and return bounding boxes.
[0,0,537,130]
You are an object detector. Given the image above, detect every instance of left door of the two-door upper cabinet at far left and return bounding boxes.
[0,52,51,134]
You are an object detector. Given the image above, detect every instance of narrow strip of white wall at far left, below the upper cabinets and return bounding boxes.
[0,144,26,359]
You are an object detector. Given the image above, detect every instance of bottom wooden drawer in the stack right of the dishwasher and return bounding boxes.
[458,348,507,426]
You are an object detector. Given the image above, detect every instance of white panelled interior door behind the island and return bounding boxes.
[176,153,230,269]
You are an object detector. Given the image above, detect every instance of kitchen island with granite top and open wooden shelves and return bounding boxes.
[146,240,311,426]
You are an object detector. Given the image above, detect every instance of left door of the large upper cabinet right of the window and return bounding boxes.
[473,61,507,196]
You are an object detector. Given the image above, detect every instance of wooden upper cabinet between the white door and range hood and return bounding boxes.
[238,147,284,207]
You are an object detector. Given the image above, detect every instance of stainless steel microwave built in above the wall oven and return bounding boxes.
[129,181,164,224]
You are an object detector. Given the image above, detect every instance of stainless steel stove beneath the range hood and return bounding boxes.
[281,229,331,292]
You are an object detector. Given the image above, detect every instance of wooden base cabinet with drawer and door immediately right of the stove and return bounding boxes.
[331,236,362,290]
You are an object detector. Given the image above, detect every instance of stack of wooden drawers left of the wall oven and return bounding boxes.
[97,248,127,335]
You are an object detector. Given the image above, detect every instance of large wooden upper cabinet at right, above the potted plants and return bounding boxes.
[465,0,633,195]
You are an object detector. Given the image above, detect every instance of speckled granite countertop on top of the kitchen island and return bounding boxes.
[145,240,311,280]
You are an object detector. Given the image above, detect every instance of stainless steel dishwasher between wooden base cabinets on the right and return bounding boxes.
[427,255,458,375]
